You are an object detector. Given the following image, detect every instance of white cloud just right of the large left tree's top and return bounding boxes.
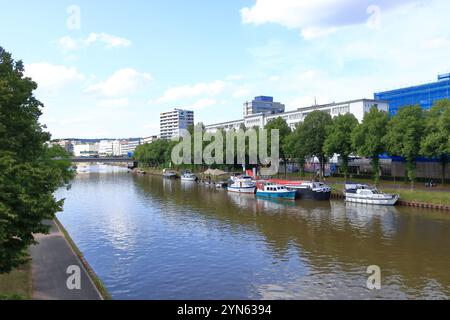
[25,62,85,90]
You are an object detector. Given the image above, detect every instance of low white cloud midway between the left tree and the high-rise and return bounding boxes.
[86,68,153,97]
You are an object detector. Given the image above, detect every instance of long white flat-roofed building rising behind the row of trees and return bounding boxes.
[205,99,389,132]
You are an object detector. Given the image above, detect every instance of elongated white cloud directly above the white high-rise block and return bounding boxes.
[156,80,226,103]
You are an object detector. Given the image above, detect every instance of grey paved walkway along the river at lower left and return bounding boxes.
[30,221,102,300]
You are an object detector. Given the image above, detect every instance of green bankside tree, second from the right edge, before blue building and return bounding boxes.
[383,106,425,188]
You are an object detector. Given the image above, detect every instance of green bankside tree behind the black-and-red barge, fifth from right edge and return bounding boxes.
[294,111,332,179]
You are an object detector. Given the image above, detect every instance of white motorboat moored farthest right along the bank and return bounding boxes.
[345,184,400,206]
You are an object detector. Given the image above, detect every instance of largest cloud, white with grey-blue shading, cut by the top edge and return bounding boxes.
[241,0,411,39]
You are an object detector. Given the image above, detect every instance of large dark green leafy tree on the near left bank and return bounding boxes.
[0,47,73,273]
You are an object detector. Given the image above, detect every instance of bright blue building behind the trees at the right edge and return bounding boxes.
[374,74,450,115]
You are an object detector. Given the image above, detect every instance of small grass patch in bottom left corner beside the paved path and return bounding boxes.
[0,262,32,300]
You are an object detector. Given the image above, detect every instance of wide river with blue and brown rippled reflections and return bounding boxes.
[58,166,450,299]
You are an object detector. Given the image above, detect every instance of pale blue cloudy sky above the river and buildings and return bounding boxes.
[0,0,450,138]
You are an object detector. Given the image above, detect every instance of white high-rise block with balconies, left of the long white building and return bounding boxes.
[160,109,194,139]
